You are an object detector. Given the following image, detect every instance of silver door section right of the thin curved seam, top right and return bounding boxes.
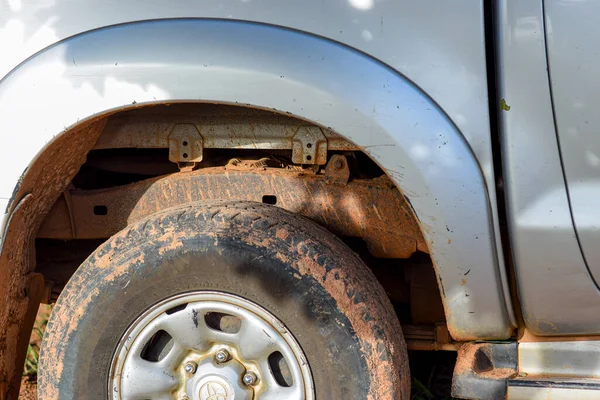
[544,0,600,288]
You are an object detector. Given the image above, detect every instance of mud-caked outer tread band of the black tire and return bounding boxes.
[41,202,410,400]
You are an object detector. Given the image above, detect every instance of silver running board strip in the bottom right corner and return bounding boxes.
[506,377,600,400]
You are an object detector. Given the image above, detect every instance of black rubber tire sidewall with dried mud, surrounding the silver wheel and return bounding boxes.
[40,205,407,399]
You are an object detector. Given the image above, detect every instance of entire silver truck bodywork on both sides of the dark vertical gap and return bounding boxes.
[0,0,600,398]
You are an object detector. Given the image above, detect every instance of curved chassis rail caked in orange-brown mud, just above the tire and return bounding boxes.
[38,167,427,258]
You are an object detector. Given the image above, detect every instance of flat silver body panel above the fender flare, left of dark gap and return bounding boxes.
[0,0,494,189]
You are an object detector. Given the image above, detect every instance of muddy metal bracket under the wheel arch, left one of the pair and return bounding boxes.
[169,124,204,172]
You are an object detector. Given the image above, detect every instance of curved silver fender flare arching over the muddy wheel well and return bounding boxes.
[0,19,512,340]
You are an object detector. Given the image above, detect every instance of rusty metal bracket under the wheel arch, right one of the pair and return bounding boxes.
[292,126,327,165]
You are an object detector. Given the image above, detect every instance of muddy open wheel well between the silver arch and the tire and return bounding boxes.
[7,104,450,356]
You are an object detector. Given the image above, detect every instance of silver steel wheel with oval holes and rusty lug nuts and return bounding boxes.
[109,292,314,400]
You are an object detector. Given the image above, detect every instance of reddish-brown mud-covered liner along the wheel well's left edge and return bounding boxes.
[0,121,104,400]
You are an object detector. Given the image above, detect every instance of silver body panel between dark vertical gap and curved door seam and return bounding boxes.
[496,0,600,335]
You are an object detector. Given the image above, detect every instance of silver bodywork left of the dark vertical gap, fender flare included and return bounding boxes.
[0,1,514,339]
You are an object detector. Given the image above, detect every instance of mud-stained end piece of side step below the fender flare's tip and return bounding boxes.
[452,342,517,400]
